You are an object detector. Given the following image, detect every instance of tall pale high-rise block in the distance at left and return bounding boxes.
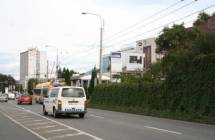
[20,48,47,85]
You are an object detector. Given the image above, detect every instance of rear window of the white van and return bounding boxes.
[61,88,85,97]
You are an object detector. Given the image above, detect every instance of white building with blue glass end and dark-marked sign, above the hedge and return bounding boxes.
[102,38,162,75]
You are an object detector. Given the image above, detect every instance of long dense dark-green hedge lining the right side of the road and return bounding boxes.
[90,54,215,123]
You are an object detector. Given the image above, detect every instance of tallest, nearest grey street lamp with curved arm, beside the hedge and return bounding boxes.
[82,12,104,84]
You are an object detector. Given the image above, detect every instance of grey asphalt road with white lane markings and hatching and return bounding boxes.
[0,101,215,140]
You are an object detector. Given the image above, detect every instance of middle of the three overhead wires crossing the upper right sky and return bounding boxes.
[105,0,196,44]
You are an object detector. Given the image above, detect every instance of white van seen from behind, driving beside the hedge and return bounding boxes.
[43,86,87,118]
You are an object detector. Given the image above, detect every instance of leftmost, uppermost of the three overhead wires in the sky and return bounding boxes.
[103,0,184,40]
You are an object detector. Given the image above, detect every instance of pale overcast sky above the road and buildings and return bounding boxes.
[0,0,215,79]
